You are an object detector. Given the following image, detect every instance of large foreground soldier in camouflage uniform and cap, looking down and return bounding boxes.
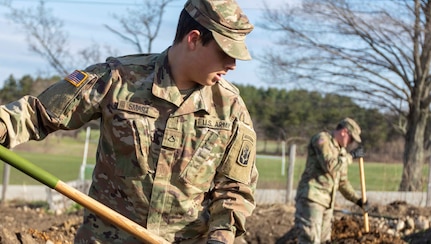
[0,0,258,243]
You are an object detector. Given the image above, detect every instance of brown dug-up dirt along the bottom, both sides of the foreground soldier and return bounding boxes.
[0,199,431,244]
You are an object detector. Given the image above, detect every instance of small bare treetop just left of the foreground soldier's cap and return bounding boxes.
[105,0,175,53]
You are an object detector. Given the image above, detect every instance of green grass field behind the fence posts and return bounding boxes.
[0,152,422,191]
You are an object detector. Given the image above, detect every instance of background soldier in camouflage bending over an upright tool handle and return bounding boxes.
[295,118,368,244]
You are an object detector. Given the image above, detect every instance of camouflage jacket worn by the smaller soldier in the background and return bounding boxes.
[296,132,359,208]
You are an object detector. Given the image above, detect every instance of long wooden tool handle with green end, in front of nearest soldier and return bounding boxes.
[0,145,169,244]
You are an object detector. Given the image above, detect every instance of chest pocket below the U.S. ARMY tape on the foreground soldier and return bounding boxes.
[180,130,220,192]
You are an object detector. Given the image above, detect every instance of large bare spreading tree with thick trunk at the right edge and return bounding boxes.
[262,0,431,191]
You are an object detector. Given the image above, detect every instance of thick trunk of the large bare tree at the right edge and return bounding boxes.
[399,109,428,191]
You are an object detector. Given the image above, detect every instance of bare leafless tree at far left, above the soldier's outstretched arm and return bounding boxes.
[2,0,116,76]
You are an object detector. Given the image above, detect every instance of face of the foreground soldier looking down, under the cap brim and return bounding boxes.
[194,40,236,86]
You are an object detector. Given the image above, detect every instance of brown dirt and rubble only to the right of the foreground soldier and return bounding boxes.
[241,202,431,244]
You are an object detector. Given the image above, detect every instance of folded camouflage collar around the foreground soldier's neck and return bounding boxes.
[152,49,213,115]
